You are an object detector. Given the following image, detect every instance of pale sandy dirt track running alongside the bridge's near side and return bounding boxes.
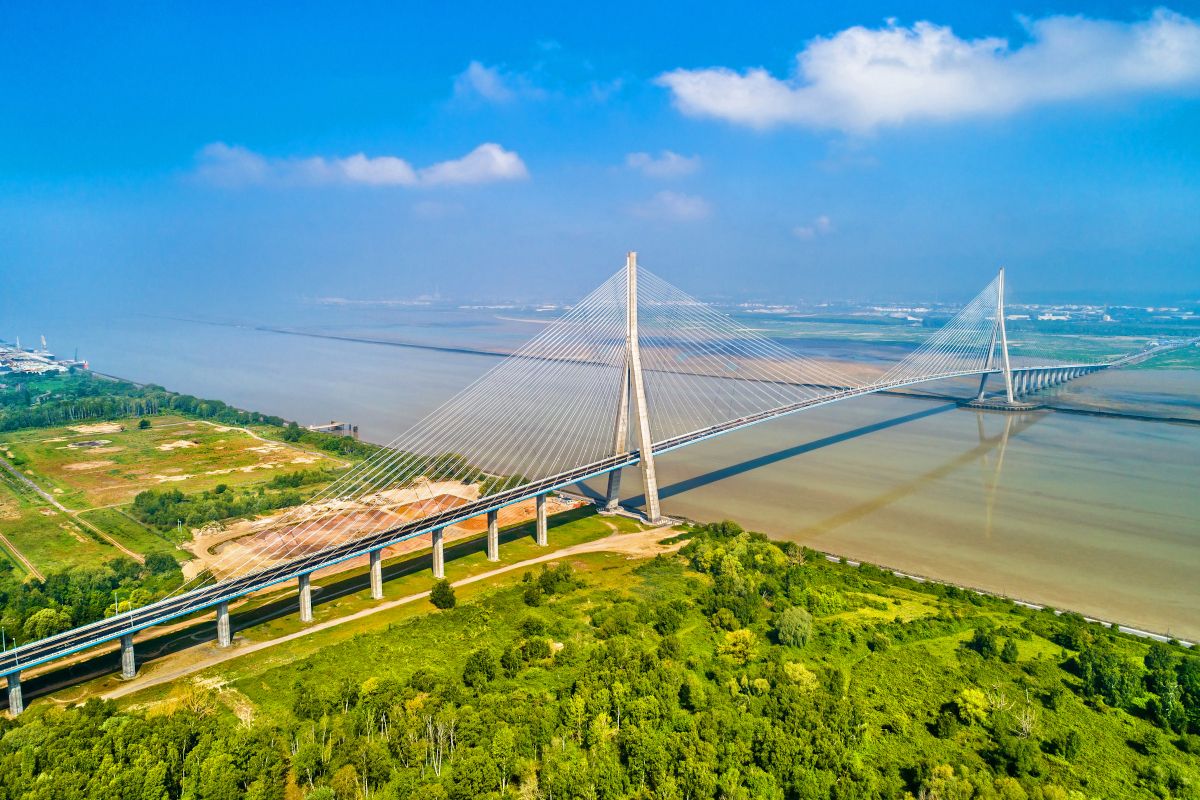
[103,525,683,703]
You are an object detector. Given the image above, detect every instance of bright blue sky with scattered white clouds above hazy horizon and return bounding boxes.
[0,2,1200,317]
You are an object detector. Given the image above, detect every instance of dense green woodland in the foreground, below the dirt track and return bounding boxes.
[0,523,1200,800]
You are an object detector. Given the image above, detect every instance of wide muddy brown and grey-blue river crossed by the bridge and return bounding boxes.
[11,309,1200,639]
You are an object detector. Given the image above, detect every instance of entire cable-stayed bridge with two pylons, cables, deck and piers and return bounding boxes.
[0,253,1200,712]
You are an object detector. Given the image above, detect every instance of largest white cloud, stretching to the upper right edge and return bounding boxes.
[656,8,1200,133]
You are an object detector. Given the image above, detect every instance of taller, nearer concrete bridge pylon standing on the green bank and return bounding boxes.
[605,251,662,523]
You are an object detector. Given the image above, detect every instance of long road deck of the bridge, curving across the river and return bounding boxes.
[0,365,1108,690]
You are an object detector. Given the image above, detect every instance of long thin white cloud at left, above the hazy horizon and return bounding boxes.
[196,142,529,187]
